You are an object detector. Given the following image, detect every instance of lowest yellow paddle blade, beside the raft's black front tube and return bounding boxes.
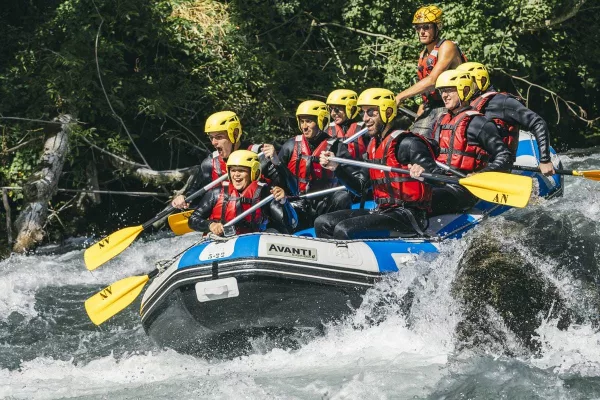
[85,275,150,325]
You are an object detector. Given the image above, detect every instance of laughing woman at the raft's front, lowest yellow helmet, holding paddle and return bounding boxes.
[188,150,298,236]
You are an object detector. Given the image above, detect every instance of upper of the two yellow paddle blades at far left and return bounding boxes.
[83,225,144,271]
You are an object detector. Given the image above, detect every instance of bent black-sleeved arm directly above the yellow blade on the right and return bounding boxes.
[467,115,512,172]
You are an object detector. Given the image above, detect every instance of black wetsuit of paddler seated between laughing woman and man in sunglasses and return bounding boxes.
[276,131,359,230]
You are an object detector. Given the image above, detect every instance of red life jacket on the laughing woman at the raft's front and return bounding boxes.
[209,181,268,235]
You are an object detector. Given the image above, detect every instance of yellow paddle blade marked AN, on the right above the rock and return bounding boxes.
[458,172,533,207]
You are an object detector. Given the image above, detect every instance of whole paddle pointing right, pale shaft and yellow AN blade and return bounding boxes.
[329,157,533,207]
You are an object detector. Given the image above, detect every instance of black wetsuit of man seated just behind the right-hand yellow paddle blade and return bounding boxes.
[431,108,512,216]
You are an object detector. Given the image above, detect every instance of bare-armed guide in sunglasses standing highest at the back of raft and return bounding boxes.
[396,5,467,136]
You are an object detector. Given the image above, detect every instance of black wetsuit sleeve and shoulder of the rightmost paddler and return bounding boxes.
[471,90,550,163]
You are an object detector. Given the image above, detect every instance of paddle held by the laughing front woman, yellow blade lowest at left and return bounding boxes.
[85,194,275,325]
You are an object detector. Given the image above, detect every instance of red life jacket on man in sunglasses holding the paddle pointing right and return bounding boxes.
[367,131,435,210]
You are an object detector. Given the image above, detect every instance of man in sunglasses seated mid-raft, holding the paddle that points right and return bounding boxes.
[315,88,440,239]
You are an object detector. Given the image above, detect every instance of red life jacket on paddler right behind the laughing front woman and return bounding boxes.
[287,135,337,194]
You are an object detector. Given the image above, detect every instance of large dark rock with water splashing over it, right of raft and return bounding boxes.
[453,232,572,356]
